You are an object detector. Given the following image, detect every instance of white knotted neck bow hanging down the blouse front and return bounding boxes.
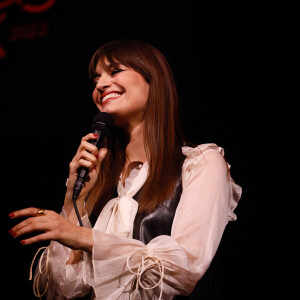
[95,163,149,238]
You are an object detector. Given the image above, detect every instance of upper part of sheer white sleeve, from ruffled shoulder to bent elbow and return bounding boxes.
[171,144,241,279]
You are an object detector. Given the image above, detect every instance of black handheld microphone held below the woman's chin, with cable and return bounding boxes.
[72,112,113,226]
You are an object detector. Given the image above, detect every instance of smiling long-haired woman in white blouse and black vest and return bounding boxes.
[10,40,241,299]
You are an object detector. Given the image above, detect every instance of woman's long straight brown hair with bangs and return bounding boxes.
[88,40,183,217]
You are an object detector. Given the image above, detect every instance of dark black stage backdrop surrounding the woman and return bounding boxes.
[0,0,300,299]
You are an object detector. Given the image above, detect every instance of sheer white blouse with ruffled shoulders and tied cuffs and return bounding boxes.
[36,144,242,300]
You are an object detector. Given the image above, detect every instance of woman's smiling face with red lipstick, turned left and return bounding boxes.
[93,60,149,128]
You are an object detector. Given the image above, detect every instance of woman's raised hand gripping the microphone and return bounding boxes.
[66,133,107,205]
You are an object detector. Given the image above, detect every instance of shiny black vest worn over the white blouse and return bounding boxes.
[133,178,218,300]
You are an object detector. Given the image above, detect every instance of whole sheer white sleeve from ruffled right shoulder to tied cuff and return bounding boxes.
[86,144,241,299]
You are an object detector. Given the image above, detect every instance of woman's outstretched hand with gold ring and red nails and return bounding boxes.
[9,207,94,252]
